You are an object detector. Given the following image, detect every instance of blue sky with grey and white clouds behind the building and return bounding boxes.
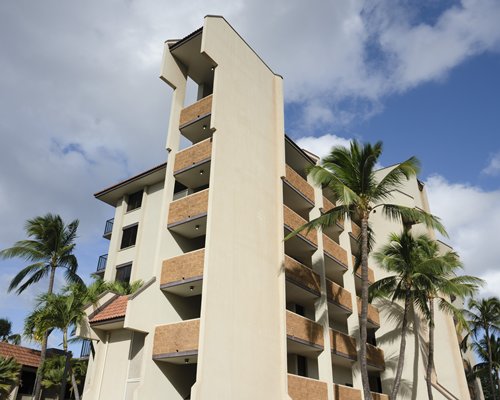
[0,0,500,345]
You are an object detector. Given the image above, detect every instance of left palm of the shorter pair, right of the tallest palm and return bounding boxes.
[370,230,429,400]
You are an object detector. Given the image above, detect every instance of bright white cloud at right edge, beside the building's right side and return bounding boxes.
[426,175,500,296]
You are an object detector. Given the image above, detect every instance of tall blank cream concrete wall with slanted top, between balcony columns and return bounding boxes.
[192,17,287,400]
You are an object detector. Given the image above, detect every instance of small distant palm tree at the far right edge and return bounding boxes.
[464,297,500,400]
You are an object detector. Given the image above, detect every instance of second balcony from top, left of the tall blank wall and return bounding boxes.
[174,138,212,188]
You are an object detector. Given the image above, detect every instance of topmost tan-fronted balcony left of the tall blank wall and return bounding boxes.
[179,95,212,143]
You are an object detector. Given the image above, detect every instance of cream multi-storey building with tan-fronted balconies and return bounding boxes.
[79,16,469,400]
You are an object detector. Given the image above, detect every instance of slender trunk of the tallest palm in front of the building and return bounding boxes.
[359,215,372,400]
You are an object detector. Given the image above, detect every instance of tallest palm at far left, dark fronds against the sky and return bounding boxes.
[0,213,81,400]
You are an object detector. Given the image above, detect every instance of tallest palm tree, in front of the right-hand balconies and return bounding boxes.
[285,140,445,400]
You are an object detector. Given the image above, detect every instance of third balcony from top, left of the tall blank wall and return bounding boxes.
[168,189,208,238]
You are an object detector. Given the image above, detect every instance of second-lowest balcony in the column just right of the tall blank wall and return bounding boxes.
[286,311,324,357]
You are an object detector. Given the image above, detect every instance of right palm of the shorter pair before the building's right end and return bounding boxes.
[418,240,484,400]
